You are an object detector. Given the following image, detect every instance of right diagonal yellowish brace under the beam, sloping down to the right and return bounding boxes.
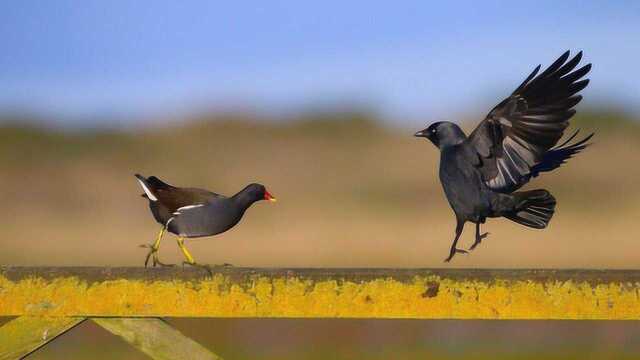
[91,318,222,360]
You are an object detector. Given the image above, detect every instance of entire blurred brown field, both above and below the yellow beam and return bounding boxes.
[0,111,640,360]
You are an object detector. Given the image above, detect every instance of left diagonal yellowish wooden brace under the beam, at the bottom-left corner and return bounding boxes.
[0,316,84,360]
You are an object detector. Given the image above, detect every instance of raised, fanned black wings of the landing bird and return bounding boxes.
[468,51,593,192]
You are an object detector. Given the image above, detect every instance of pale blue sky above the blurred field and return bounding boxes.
[0,0,640,123]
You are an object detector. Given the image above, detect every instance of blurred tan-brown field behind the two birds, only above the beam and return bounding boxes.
[0,111,640,268]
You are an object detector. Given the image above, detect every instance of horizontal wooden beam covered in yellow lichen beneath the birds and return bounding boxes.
[0,267,640,320]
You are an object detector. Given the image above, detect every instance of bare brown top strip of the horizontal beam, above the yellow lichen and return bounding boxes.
[5,266,640,283]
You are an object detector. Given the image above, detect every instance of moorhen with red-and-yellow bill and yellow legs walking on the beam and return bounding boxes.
[135,174,275,266]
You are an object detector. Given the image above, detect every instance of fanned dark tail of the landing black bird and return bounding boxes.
[502,189,556,229]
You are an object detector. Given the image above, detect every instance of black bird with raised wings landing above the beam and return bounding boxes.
[415,51,593,261]
